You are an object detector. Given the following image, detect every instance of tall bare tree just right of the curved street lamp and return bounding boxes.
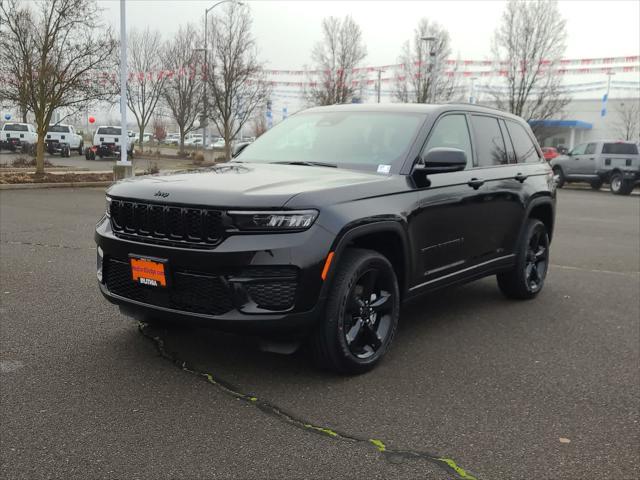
[206,2,270,160]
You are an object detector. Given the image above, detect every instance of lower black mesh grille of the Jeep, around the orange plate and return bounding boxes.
[103,258,233,315]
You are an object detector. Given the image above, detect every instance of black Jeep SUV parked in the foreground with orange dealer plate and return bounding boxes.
[95,104,555,373]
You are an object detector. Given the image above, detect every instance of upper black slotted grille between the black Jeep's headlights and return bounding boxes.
[110,199,224,248]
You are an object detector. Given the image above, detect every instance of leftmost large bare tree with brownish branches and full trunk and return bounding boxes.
[0,0,116,175]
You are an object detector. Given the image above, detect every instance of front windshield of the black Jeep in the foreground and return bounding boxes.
[237,112,424,169]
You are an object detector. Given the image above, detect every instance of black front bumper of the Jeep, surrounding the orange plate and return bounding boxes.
[95,217,333,333]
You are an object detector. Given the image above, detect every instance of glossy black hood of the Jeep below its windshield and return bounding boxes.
[107,163,391,208]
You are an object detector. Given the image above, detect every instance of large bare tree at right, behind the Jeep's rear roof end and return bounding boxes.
[493,0,570,129]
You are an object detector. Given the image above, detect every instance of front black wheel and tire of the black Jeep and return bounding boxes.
[310,249,400,374]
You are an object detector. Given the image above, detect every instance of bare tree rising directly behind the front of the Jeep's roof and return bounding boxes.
[306,16,367,105]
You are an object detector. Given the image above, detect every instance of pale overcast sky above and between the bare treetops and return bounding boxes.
[98,0,640,69]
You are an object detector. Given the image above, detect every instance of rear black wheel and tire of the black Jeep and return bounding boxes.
[496,218,549,300]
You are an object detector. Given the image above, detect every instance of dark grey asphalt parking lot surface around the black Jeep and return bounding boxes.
[0,189,640,480]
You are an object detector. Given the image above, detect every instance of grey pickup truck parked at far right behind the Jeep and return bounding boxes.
[551,140,640,195]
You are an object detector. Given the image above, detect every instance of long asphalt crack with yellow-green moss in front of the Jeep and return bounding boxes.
[138,322,480,480]
